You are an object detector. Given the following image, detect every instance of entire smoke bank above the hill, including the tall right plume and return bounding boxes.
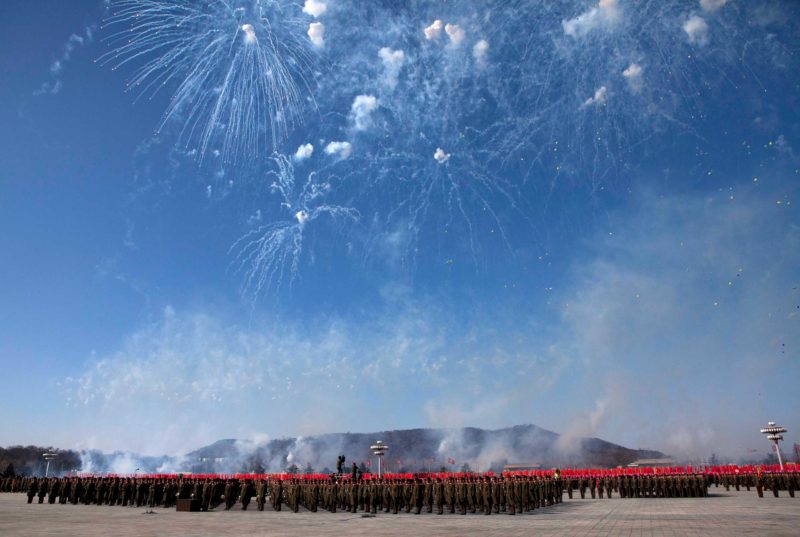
[57,174,800,463]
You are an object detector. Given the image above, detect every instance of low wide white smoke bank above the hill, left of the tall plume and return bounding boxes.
[62,289,576,454]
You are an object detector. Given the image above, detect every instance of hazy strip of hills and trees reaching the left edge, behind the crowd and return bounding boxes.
[0,425,664,475]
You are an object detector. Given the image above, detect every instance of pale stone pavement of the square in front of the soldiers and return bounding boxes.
[0,488,800,537]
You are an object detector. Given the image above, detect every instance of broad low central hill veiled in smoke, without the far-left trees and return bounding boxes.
[184,425,664,471]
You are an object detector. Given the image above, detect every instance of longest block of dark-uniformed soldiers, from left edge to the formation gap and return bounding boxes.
[0,475,564,515]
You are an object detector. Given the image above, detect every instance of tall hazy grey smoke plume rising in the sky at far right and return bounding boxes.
[560,186,800,456]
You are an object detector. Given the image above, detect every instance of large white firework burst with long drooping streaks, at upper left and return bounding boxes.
[100,0,315,161]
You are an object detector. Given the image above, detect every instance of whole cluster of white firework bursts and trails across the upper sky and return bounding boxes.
[106,0,797,292]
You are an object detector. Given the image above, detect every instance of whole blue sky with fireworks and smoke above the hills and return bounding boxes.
[0,0,800,457]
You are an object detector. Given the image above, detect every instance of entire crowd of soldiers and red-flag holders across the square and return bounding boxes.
[0,460,800,515]
